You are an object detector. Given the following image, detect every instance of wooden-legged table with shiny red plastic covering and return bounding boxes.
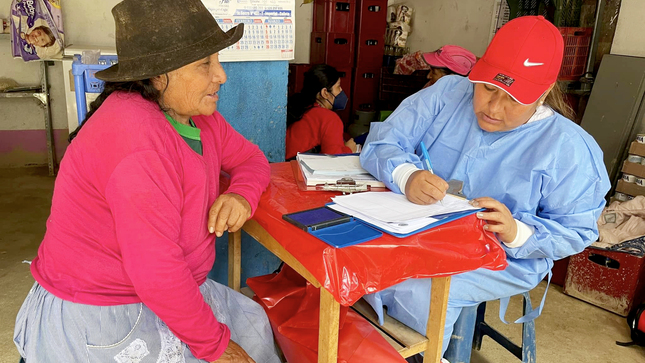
[229,163,506,363]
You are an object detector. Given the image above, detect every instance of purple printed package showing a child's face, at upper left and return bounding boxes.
[10,0,65,61]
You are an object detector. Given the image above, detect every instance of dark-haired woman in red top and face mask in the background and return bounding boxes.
[285,64,357,160]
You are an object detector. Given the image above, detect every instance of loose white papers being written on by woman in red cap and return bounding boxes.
[329,192,477,234]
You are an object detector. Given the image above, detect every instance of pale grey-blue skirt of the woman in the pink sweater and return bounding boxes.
[14,280,280,363]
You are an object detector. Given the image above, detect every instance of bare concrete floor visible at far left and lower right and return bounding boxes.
[0,168,645,363]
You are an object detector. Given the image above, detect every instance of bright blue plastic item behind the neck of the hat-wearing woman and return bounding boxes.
[72,54,118,125]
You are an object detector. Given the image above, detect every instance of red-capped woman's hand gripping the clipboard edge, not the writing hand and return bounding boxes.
[470,197,517,243]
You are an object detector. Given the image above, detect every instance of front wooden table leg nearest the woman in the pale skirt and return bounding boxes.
[318,287,340,363]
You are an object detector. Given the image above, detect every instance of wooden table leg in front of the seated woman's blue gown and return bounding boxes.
[423,276,450,363]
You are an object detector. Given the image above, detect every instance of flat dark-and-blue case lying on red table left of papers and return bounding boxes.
[282,207,383,248]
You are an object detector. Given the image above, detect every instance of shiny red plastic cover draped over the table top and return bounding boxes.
[247,163,507,306]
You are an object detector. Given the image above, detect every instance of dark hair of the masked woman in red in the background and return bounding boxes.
[287,64,340,127]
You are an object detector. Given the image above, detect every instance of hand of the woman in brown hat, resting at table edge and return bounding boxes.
[208,193,251,237]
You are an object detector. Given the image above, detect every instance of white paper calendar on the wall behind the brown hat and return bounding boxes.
[202,0,296,62]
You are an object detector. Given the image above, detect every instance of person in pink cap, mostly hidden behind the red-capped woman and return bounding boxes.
[423,45,477,88]
